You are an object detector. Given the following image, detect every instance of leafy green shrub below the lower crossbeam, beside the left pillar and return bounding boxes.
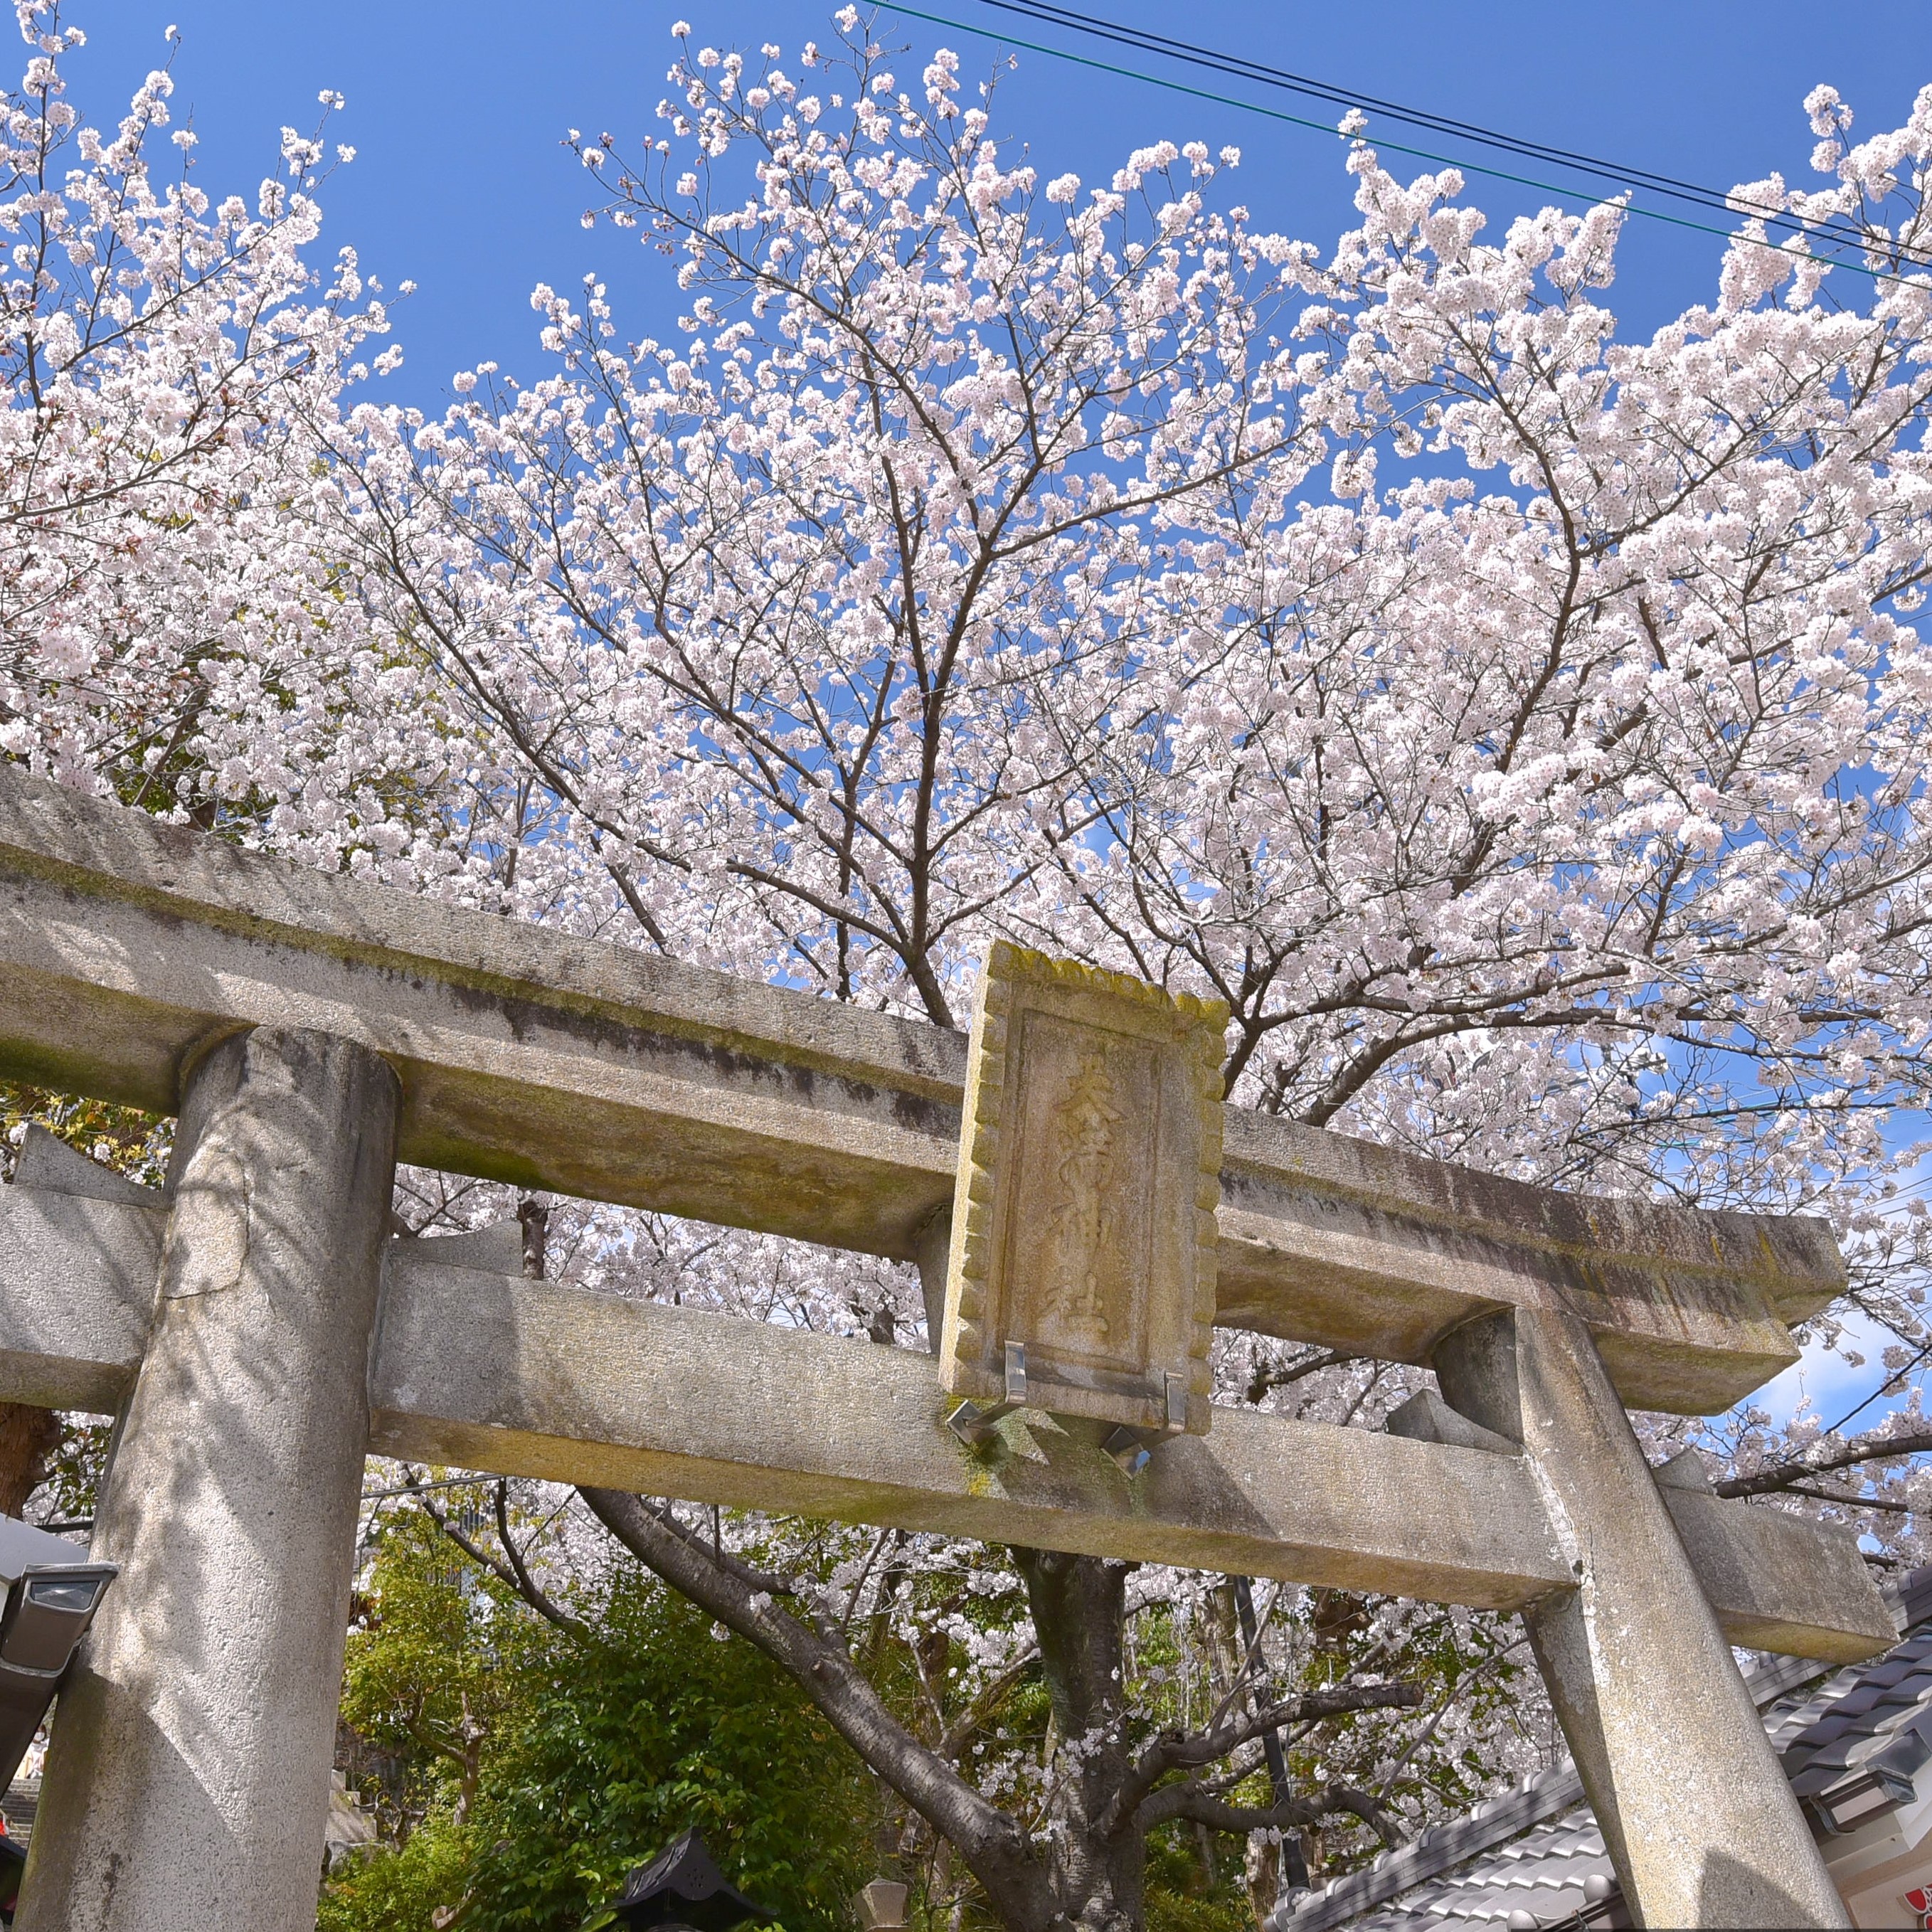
[321,1513,877,1932]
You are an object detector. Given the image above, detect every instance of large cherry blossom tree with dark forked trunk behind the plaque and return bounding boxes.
[301,10,1932,1926]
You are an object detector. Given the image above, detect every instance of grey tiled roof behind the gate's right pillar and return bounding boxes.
[1271,1567,1932,1932]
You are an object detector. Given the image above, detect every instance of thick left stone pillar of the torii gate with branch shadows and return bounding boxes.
[19,1028,398,1932]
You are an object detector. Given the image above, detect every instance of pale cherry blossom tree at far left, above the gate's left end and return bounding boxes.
[0,0,442,866]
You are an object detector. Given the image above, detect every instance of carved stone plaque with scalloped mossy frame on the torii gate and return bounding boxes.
[939,941,1227,1433]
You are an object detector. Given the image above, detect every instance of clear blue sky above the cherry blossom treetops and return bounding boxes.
[53,0,1932,405]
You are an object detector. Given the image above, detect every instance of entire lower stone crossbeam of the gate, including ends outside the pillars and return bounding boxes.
[0,1140,1894,1662]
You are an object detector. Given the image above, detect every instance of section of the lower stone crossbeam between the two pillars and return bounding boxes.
[371,1242,1567,1605]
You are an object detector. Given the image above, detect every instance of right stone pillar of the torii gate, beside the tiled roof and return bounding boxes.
[1435,1308,1847,1926]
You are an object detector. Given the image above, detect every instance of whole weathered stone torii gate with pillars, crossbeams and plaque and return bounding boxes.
[0,771,1895,1932]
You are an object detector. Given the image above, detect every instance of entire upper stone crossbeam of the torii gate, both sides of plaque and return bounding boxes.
[0,769,1843,1414]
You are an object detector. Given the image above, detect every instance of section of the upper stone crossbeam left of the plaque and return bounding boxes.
[0,769,966,1256]
